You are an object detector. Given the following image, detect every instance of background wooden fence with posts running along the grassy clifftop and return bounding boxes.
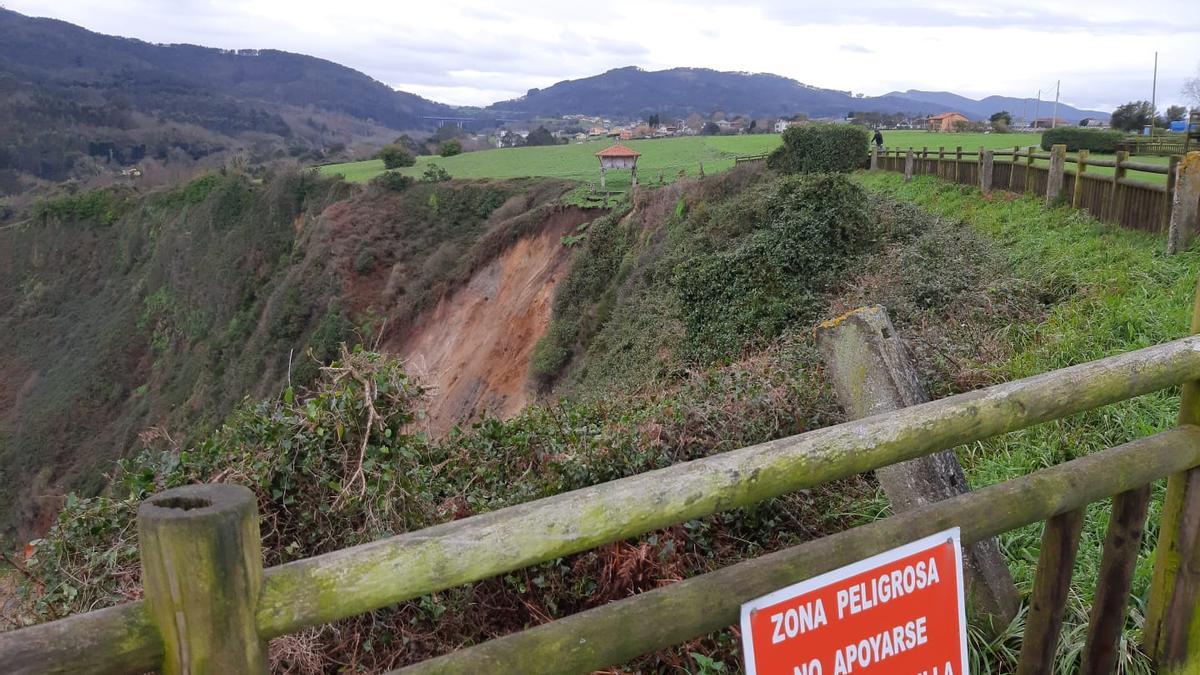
[871,145,1200,248]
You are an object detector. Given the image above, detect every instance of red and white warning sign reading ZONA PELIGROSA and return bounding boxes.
[742,527,970,675]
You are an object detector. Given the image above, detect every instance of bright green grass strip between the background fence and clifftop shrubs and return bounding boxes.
[859,173,1200,673]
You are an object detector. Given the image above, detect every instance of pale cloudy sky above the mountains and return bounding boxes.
[0,0,1200,109]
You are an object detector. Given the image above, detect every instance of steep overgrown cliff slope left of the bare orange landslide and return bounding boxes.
[0,173,584,538]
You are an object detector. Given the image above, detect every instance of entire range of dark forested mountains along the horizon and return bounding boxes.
[0,7,1108,196]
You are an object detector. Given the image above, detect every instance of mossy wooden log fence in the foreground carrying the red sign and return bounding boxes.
[0,300,1200,675]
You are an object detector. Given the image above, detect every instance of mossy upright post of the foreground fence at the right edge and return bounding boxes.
[1142,266,1200,675]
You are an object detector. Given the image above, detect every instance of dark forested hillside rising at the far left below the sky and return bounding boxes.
[0,7,450,189]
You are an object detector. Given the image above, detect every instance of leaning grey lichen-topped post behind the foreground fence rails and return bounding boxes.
[817,306,1020,631]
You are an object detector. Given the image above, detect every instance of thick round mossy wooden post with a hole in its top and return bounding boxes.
[138,483,266,675]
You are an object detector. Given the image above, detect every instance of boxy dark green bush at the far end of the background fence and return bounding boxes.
[767,124,869,173]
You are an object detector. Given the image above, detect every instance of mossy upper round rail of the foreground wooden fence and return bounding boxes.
[11,338,1200,673]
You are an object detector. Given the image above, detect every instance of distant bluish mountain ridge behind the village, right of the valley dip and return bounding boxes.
[492,66,1109,123]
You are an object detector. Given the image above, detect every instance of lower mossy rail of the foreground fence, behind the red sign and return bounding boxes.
[395,426,1200,675]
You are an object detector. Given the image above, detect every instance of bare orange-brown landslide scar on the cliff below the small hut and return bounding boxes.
[388,209,595,436]
